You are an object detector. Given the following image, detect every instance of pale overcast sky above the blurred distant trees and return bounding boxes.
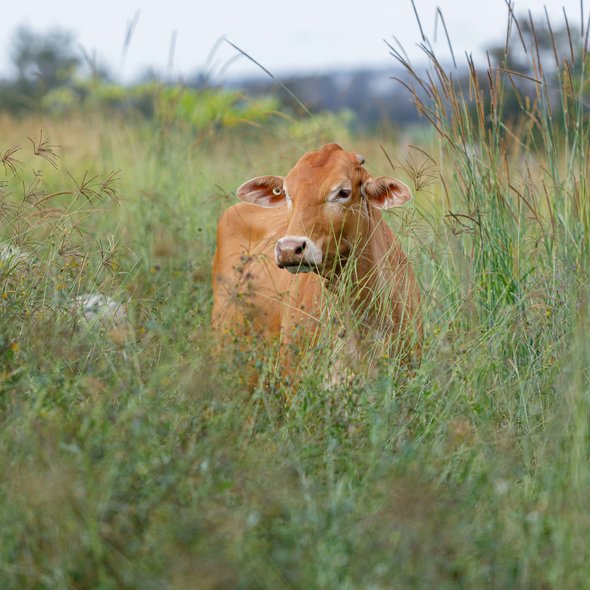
[0,0,590,80]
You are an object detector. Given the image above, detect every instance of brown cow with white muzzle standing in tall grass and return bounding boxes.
[213,144,422,382]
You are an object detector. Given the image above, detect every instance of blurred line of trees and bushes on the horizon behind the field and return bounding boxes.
[0,18,588,129]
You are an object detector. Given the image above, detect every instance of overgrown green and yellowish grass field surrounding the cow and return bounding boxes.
[0,22,590,590]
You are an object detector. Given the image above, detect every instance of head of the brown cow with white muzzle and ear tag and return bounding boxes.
[237,144,412,274]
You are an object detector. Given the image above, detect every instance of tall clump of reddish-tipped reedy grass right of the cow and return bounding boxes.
[389,5,590,323]
